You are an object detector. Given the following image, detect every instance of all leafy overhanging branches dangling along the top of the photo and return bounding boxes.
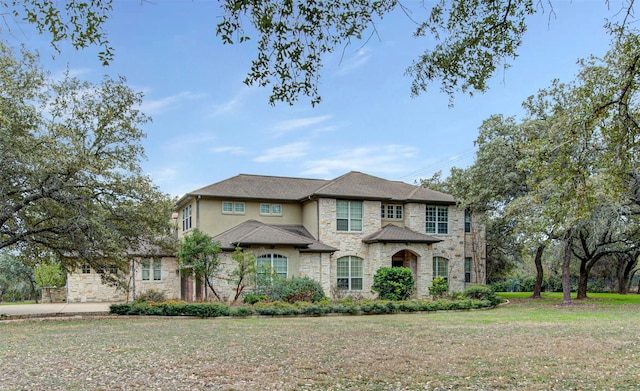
[0,0,635,105]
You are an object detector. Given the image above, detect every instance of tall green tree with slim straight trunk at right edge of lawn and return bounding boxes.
[521,30,640,303]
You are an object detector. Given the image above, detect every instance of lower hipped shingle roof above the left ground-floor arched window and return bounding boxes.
[213,220,338,252]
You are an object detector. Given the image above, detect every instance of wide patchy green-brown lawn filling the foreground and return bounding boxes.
[0,294,640,391]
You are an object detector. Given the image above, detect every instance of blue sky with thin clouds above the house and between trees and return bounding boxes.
[2,0,621,196]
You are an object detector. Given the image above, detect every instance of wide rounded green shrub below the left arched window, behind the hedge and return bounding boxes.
[255,277,326,304]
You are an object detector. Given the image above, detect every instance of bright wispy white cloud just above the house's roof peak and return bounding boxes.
[302,145,418,177]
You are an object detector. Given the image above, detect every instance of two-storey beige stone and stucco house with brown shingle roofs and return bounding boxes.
[176,171,486,299]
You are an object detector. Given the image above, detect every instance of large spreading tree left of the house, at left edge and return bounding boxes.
[0,43,172,279]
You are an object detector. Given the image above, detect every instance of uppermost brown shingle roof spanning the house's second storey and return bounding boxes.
[178,171,455,205]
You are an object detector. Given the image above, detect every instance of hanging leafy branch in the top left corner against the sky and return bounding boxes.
[0,0,113,65]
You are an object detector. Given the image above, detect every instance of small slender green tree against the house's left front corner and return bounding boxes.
[178,228,222,301]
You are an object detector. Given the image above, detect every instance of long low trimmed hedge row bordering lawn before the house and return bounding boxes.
[111,286,501,318]
